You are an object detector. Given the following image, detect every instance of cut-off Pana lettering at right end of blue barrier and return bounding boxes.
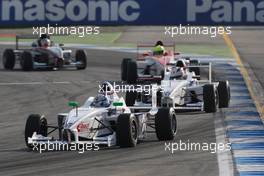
[187,0,264,23]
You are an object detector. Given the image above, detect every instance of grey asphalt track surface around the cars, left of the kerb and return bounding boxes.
[0,46,222,176]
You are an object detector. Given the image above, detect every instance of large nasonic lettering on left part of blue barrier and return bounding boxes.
[0,0,140,22]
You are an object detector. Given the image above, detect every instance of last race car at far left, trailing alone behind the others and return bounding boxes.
[3,34,87,71]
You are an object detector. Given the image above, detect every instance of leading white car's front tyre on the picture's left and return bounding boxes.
[25,114,48,148]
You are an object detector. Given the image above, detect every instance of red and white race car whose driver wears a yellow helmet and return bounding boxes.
[121,41,200,84]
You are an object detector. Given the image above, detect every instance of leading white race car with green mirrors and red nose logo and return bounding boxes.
[25,82,177,148]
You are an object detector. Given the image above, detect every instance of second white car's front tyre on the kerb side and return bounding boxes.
[203,84,218,113]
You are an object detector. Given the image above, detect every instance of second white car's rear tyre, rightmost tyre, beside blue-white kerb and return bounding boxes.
[217,81,230,108]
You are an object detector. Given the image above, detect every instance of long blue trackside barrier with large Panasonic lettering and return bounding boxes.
[0,0,264,27]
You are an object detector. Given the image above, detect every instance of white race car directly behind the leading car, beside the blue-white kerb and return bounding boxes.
[126,63,231,113]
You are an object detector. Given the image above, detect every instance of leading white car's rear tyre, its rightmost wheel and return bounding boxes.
[155,108,177,141]
